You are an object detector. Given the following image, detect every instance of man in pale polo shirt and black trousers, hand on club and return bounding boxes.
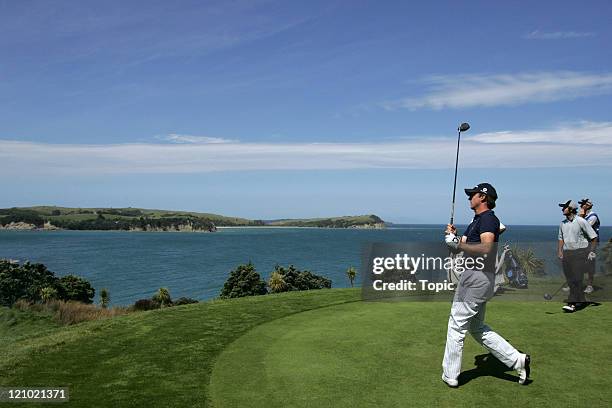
[557,200,597,313]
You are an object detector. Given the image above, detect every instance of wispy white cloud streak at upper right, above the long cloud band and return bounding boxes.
[383,71,612,110]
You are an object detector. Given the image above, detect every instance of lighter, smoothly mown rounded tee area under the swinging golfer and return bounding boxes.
[211,302,612,407]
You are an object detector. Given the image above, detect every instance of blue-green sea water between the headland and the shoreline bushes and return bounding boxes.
[0,225,612,305]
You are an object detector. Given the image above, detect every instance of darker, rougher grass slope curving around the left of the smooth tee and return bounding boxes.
[0,289,359,407]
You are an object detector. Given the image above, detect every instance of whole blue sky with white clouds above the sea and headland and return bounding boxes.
[0,1,612,225]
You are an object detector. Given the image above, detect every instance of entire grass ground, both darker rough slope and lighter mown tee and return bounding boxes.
[0,289,612,407]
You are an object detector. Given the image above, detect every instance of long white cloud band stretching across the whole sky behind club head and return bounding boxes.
[0,122,612,176]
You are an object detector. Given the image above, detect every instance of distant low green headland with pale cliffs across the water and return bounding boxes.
[0,206,386,232]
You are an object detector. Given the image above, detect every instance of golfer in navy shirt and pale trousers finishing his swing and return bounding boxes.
[442,183,531,387]
